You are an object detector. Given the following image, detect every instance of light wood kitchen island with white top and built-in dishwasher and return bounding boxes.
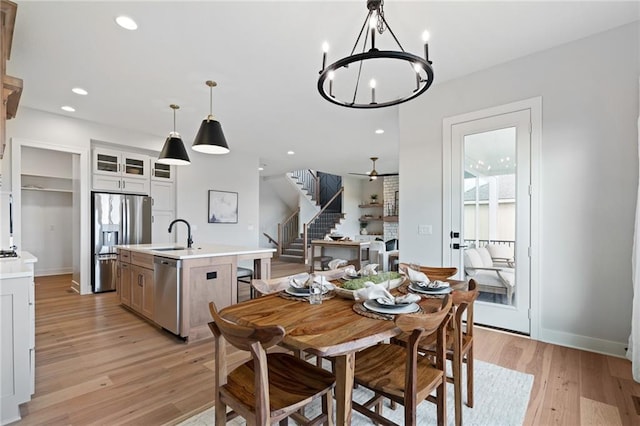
[116,244,275,342]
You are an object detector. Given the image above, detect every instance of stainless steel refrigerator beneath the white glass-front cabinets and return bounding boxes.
[91,192,151,293]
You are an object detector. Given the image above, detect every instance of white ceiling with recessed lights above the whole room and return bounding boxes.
[7,0,639,179]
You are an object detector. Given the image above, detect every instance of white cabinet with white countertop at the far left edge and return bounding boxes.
[0,251,38,425]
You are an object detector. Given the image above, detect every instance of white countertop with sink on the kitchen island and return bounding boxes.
[116,244,276,259]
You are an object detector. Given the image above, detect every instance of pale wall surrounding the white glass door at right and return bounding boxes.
[400,23,640,355]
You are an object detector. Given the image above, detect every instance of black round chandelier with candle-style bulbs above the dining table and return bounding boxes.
[318,0,433,108]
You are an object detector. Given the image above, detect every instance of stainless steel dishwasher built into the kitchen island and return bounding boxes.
[153,256,182,335]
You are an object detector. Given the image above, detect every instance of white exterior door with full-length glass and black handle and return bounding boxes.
[443,102,532,334]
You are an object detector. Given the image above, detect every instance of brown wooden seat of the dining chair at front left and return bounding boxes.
[220,353,335,417]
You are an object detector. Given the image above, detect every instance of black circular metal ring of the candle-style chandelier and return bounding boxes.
[318,49,433,108]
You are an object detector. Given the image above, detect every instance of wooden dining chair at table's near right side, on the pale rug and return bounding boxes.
[353,296,451,425]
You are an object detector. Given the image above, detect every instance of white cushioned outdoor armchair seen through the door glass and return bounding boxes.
[464,247,516,305]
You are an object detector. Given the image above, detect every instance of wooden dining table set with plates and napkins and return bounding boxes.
[220,281,466,425]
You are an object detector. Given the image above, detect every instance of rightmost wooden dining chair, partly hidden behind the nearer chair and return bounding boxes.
[392,279,479,426]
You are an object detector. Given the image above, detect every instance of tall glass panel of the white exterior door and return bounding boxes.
[463,127,517,305]
